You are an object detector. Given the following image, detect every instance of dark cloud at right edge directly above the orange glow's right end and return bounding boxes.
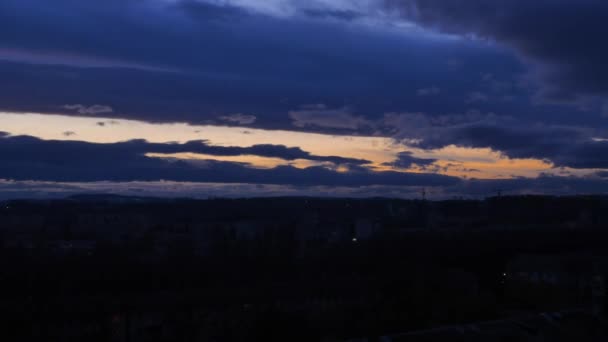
[385,111,608,169]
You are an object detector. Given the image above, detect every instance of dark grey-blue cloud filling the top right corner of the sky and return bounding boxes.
[386,0,608,101]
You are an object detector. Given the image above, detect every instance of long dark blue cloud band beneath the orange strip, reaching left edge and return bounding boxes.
[0,136,459,186]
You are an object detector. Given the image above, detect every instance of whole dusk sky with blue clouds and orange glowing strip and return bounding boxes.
[0,0,608,199]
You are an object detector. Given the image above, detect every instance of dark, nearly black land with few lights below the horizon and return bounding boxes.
[0,196,608,342]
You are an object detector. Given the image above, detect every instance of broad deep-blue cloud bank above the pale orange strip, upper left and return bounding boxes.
[0,0,522,127]
